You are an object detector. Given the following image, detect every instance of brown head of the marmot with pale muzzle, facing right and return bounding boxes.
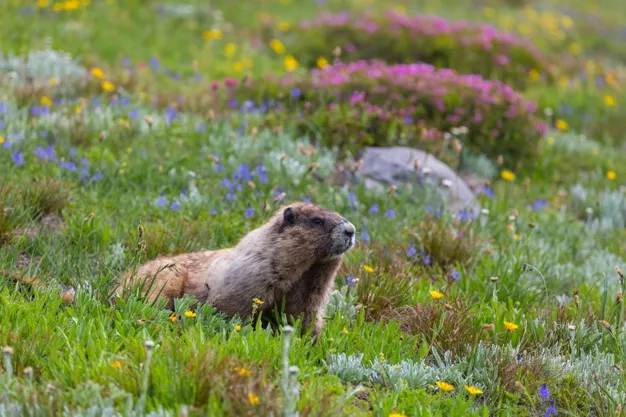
[275,202,356,260]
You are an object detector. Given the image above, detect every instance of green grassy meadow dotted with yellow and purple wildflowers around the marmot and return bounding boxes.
[0,0,626,417]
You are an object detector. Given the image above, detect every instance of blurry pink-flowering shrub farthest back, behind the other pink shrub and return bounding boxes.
[289,11,553,87]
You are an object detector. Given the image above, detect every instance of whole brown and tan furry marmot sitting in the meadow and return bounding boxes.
[118,202,356,337]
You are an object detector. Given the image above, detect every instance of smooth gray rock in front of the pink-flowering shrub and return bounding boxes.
[356,146,480,216]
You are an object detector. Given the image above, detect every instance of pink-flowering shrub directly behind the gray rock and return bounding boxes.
[238,61,545,168]
